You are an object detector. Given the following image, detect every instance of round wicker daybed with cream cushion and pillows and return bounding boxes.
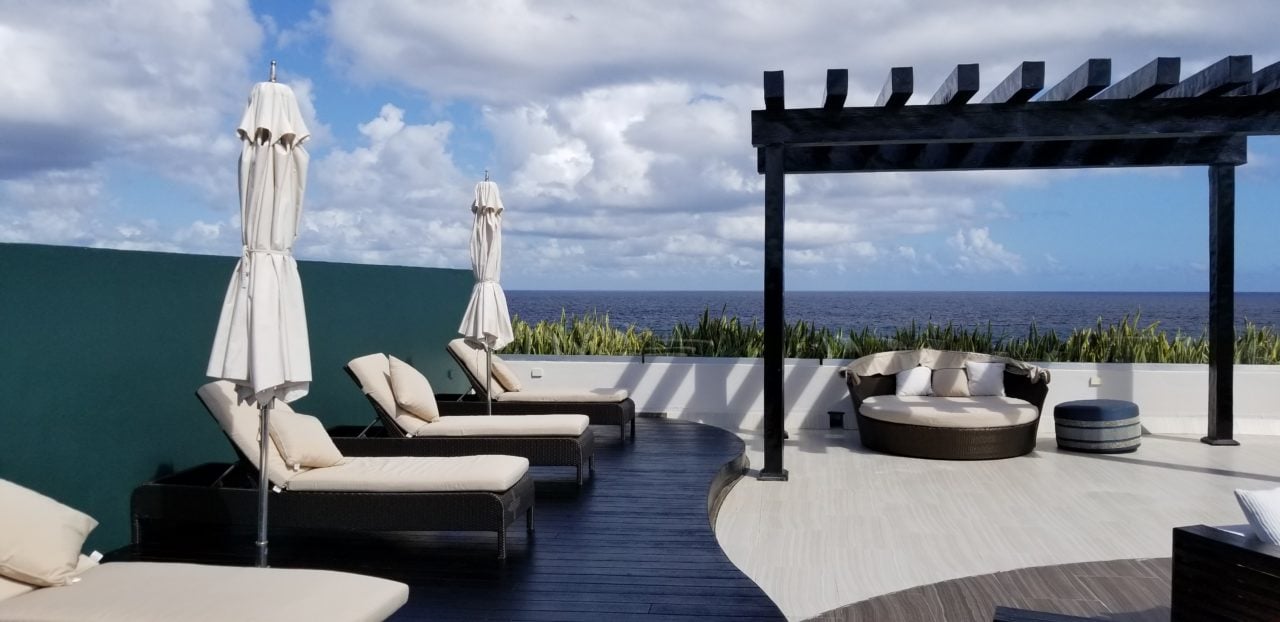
[842,349,1050,459]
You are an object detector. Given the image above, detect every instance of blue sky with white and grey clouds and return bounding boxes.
[0,0,1280,292]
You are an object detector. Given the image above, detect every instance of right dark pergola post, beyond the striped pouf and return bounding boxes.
[1201,164,1240,445]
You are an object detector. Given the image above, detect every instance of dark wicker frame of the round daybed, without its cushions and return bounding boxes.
[845,371,1048,459]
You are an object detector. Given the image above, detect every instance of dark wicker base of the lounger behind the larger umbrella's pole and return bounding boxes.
[131,459,534,559]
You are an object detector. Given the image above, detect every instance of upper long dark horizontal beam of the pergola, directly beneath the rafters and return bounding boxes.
[751,97,1280,147]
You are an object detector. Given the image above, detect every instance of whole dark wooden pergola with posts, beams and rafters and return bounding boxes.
[751,56,1280,480]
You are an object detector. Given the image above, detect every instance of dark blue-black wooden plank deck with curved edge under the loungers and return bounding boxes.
[111,419,782,622]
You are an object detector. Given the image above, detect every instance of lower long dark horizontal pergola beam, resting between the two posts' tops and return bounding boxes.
[756,136,1247,174]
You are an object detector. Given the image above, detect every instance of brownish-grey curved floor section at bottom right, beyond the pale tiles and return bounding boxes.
[814,558,1171,622]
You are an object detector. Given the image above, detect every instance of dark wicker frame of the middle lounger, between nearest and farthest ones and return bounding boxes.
[333,365,595,485]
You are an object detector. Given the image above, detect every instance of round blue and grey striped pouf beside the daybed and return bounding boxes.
[1053,399,1142,453]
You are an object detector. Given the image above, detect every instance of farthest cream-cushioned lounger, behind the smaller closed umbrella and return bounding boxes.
[445,339,636,440]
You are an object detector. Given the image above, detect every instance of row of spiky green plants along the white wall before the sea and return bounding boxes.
[503,310,1280,365]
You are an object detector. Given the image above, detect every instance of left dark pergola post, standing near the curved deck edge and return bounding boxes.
[760,145,787,481]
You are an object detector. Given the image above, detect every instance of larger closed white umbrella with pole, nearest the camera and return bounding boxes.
[207,69,311,566]
